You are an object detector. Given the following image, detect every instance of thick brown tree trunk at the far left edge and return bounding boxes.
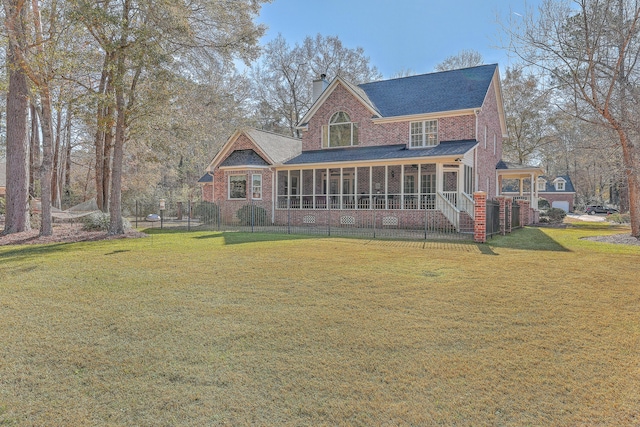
[3,1,31,234]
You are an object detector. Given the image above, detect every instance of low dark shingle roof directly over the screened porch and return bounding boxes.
[284,140,478,165]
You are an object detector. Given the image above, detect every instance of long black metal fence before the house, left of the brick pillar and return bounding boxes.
[132,201,473,240]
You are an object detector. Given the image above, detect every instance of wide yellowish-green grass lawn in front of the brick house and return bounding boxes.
[0,224,640,426]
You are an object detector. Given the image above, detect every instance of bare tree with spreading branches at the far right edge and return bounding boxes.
[505,0,640,238]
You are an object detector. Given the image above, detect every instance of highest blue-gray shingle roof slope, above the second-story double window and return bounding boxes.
[359,64,498,117]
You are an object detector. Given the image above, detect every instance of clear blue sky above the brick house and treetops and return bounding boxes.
[258,0,541,77]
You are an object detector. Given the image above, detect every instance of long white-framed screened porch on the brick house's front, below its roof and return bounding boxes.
[276,163,473,217]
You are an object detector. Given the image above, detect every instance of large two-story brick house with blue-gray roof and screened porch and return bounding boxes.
[200,64,539,237]
